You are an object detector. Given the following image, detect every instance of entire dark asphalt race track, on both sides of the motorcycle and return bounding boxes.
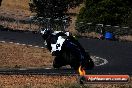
[0,30,132,75]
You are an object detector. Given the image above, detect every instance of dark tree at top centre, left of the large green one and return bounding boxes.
[29,0,83,19]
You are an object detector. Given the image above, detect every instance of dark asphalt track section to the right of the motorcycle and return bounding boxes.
[80,38,132,74]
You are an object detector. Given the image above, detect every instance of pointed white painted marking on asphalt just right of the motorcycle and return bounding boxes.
[91,56,108,66]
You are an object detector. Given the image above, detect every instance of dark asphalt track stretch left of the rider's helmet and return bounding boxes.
[0,30,44,47]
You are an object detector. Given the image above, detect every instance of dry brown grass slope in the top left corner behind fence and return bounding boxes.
[0,0,31,19]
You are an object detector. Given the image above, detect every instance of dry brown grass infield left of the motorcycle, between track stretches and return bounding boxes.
[0,43,53,68]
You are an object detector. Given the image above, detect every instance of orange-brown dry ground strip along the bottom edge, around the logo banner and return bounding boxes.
[0,75,132,88]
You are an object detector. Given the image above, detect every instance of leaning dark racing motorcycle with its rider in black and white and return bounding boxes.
[40,29,94,70]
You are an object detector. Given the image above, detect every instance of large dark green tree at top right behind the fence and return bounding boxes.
[77,0,132,26]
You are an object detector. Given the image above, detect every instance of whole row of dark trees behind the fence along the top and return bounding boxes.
[0,0,132,35]
